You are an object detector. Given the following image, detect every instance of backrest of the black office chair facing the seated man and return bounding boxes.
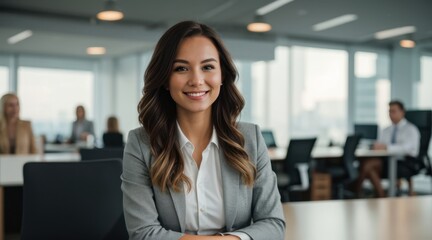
[342,135,361,180]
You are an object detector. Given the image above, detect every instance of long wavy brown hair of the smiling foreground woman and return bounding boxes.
[138,21,256,191]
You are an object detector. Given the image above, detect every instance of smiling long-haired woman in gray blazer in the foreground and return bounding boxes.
[121,21,285,240]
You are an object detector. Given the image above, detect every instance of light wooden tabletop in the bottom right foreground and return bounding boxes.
[283,196,432,240]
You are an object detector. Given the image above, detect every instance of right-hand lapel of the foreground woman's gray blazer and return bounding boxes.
[219,151,240,231]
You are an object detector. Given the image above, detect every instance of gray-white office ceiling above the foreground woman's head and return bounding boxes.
[0,0,432,57]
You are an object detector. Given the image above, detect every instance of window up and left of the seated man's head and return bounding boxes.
[354,51,390,127]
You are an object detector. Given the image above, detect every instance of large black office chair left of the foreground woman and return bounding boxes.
[21,160,128,240]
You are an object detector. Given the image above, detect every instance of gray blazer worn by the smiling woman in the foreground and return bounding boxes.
[121,123,285,240]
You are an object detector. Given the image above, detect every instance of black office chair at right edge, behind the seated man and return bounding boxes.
[397,110,432,193]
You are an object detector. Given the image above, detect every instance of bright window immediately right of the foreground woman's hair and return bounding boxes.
[236,47,289,146]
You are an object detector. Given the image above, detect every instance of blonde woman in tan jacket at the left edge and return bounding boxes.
[0,93,37,154]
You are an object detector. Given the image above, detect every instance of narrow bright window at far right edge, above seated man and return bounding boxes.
[417,56,432,109]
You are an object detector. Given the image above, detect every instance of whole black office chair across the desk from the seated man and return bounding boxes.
[325,135,360,199]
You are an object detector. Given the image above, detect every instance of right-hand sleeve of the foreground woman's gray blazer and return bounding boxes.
[236,124,285,240]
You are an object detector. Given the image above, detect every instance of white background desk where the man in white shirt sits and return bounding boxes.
[268,147,398,197]
